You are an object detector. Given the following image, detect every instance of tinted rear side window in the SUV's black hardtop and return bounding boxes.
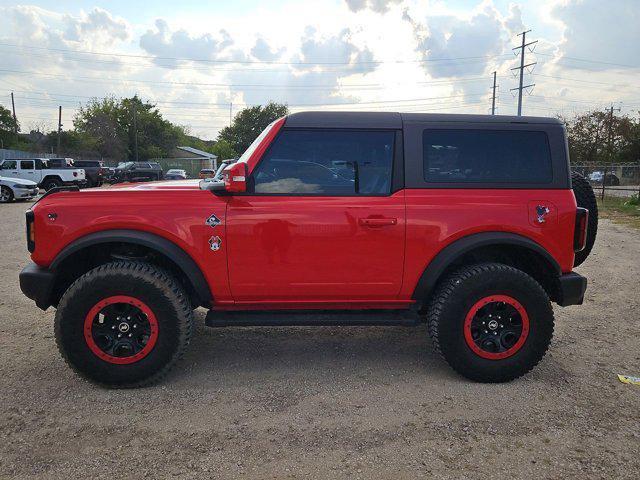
[422,130,553,184]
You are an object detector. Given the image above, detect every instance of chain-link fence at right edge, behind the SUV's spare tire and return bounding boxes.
[571,164,640,199]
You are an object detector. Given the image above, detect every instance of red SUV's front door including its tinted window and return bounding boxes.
[226,129,405,303]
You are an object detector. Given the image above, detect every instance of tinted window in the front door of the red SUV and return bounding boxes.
[253,130,395,195]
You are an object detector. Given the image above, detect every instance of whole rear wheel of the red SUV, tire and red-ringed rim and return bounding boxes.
[427,263,553,382]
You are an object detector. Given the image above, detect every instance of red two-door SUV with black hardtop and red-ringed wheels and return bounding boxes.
[20,112,597,386]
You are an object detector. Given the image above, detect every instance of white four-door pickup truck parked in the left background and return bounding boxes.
[0,158,87,191]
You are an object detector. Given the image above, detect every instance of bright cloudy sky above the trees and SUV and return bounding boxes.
[0,0,640,139]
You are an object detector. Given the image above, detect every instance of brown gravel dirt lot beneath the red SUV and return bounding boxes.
[0,204,640,479]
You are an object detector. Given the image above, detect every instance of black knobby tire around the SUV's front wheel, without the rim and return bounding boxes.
[55,261,193,388]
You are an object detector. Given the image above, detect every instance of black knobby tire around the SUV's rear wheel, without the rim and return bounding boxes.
[427,263,554,383]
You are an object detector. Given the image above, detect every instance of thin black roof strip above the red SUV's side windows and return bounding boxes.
[285,112,562,129]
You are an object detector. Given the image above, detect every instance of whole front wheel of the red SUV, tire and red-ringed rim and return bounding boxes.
[55,261,193,387]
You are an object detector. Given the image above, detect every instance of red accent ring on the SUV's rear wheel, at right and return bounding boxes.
[464,295,529,360]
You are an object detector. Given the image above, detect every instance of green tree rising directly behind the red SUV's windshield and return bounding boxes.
[218,102,289,154]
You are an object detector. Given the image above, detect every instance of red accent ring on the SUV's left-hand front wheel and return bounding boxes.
[84,295,158,365]
